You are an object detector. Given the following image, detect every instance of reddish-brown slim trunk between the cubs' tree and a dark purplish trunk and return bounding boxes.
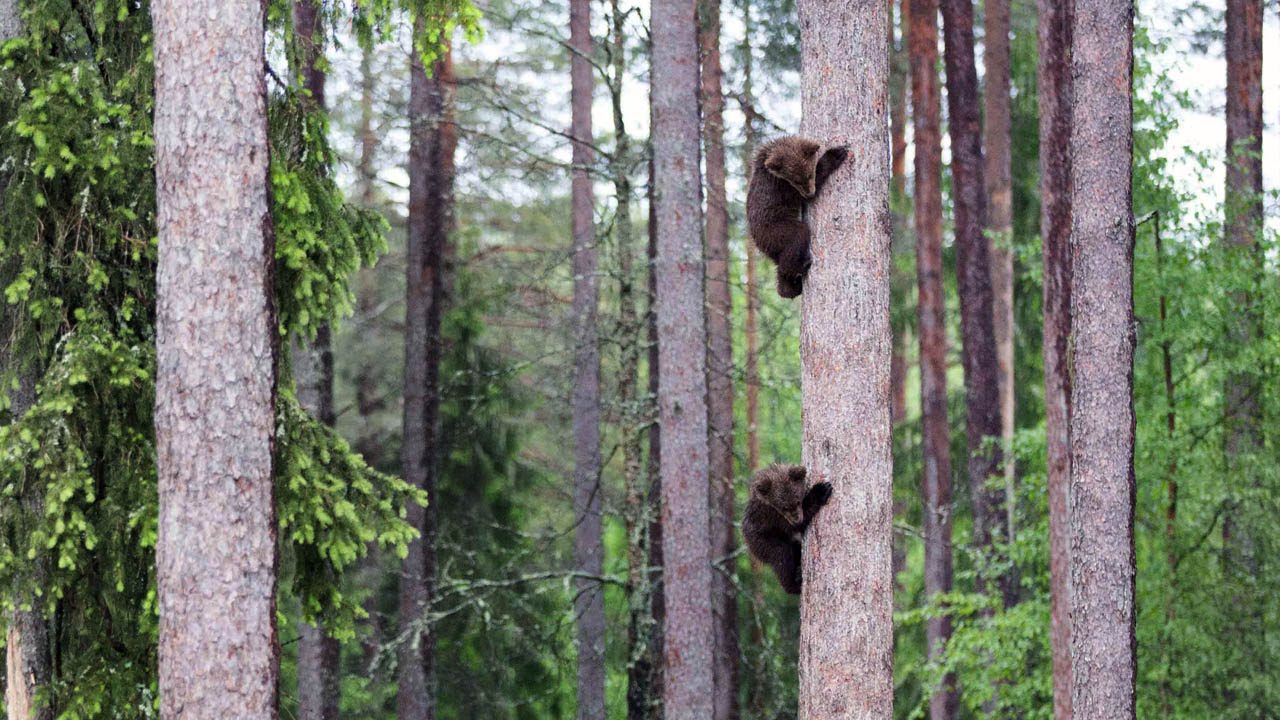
[910,0,960,707]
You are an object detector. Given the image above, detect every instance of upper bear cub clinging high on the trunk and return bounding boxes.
[746,136,849,299]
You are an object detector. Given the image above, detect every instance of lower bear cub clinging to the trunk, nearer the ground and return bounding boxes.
[742,465,831,594]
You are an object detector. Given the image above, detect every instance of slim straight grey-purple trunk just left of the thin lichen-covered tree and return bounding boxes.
[568,0,604,720]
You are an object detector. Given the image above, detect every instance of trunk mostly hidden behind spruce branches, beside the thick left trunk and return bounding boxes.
[293,0,342,720]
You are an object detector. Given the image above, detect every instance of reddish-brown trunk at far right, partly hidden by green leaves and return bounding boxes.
[1222,0,1263,574]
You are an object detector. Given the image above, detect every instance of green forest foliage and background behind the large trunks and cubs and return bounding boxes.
[0,0,1280,720]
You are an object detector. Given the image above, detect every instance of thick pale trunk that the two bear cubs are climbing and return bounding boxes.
[797,0,893,720]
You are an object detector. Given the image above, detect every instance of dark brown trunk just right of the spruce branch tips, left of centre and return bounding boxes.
[397,39,456,720]
